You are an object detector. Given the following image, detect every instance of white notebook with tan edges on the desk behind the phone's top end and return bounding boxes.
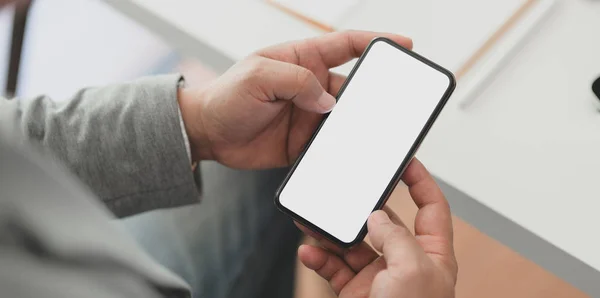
[266,0,555,107]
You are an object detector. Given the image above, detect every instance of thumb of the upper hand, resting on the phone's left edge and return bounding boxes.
[245,57,336,113]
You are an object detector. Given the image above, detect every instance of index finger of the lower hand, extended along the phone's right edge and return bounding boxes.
[402,158,453,245]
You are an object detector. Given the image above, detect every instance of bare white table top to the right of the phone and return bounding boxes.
[421,0,600,270]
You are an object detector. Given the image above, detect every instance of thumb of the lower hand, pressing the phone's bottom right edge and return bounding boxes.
[367,210,424,266]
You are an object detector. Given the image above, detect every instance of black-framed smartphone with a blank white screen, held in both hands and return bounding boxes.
[275,38,456,247]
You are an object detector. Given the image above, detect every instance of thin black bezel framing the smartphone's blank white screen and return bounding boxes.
[275,37,456,248]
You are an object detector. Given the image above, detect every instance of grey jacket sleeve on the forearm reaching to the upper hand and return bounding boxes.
[0,75,199,217]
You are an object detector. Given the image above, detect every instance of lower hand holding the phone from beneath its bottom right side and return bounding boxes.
[298,159,458,298]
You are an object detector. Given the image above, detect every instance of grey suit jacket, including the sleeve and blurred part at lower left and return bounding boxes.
[0,76,199,297]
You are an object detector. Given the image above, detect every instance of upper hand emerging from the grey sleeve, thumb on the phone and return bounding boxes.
[179,31,412,169]
